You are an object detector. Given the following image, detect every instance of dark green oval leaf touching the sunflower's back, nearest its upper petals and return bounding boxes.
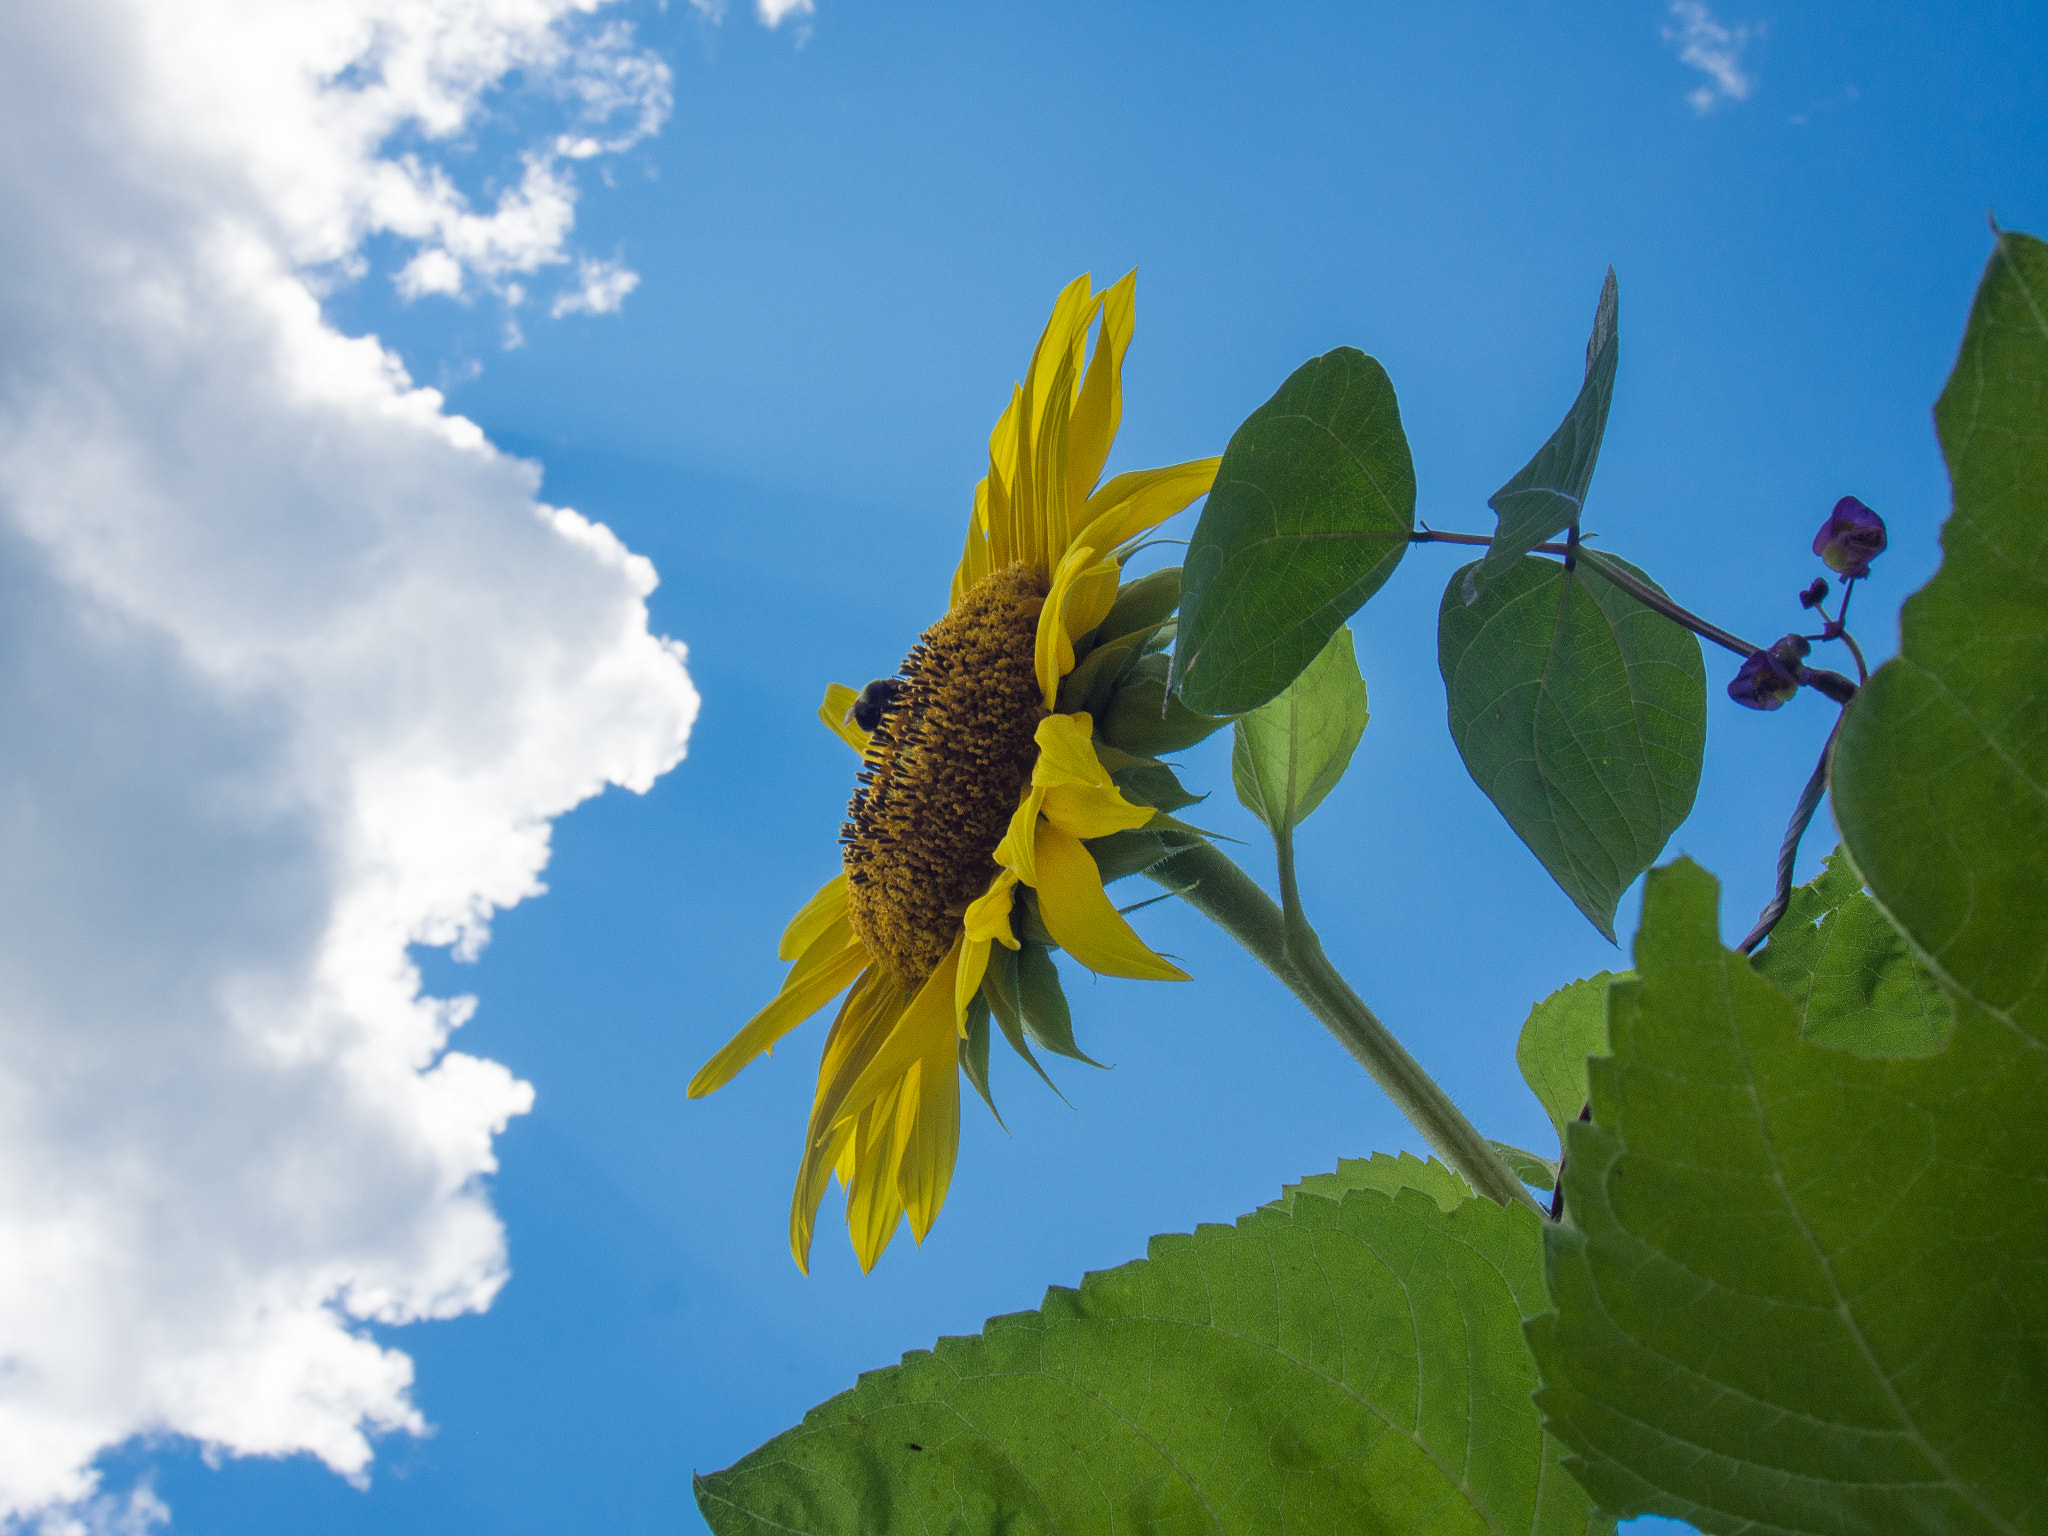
[1171,346,1415,715]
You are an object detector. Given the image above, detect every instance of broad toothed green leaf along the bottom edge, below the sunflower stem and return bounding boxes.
[696,1157,1614,1536]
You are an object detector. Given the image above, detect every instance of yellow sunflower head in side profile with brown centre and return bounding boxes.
[688,272,1223,1270]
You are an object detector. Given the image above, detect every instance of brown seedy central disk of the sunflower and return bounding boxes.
[840,565,1047,991]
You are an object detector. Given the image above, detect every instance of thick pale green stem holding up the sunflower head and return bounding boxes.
[1147,838,1542,1212]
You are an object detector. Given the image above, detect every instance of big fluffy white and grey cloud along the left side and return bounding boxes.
[0,0,696,1536]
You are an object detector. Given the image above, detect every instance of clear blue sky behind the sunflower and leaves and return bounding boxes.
[0,0,2048,1536]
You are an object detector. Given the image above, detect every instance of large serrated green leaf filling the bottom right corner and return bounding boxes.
[1528,862,2048,1536]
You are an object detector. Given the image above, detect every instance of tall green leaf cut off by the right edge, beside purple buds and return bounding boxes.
[1831,233,2048,1040]
